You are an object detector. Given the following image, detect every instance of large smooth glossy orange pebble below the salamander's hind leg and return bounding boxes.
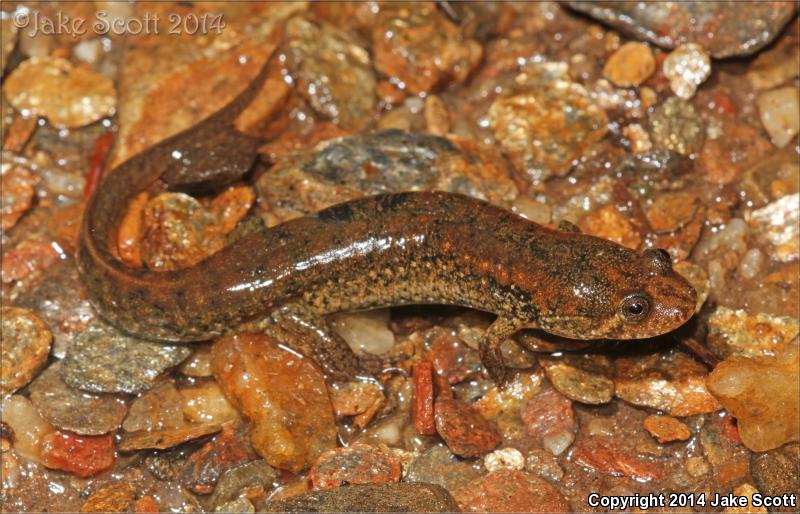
[212,335,336,473]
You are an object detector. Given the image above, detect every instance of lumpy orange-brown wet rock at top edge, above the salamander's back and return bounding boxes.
[372,2,483,94]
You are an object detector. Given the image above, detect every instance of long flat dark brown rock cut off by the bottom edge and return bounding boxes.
[263,482,459,512]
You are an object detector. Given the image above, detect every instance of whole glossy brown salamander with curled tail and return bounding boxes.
[78,53,695,380]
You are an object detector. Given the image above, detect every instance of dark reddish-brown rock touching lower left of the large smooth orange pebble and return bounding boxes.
[176,422,258,494]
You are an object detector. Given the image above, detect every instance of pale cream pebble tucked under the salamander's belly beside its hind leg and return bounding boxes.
[330,309,394,355]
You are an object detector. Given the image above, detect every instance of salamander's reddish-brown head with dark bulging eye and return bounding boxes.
[538,243,697,339]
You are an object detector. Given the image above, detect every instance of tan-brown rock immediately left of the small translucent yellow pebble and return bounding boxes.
[122,380,186,432]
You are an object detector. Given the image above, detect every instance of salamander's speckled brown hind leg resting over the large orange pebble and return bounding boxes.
[266,302,381,381]
